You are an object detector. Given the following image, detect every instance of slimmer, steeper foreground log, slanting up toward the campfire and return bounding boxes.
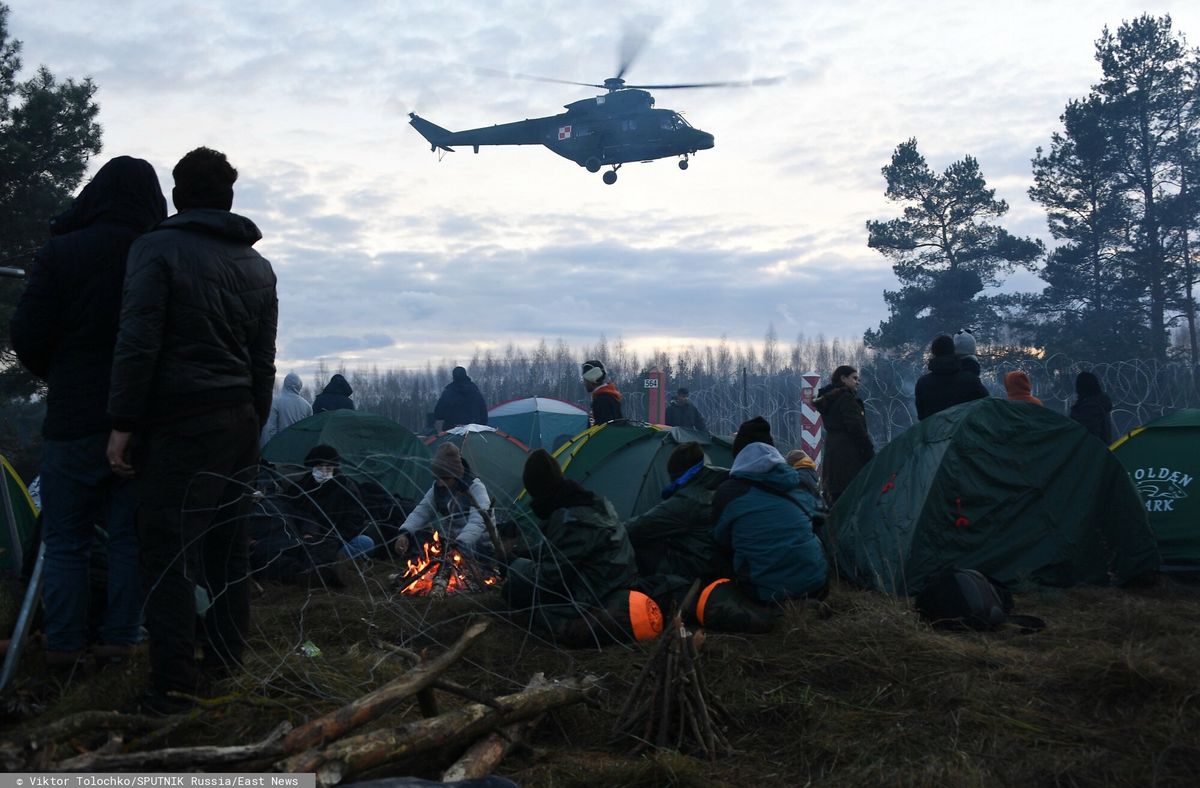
[283,621,487,753]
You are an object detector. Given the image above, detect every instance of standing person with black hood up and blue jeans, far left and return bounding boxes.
[10,156,167,667]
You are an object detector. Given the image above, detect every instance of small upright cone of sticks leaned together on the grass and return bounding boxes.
[613,582,733,760]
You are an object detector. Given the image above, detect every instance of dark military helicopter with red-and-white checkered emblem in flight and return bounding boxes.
[408,47,778,186]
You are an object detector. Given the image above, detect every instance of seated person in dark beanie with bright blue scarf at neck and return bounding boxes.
[625,441,730,583]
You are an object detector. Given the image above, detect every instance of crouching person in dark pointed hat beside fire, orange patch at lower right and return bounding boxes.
[502,449,662,646]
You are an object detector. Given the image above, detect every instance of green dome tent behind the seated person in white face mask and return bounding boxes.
[263,410,433,500]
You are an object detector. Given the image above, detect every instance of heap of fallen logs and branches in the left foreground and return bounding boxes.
[16,622,599,786]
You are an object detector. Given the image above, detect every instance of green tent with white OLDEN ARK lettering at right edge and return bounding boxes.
[1112,409,1200,572]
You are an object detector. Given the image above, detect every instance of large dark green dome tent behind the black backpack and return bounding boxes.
[824,398,1159,595]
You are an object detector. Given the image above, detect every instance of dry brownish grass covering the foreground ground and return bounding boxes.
[0,567,1200,787]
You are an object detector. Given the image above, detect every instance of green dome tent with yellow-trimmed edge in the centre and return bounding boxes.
[554,421,733,519]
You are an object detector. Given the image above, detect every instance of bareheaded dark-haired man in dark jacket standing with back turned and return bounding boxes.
[108,148,278,714]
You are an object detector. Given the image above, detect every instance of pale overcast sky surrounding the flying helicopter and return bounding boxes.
[4,0,1200,369]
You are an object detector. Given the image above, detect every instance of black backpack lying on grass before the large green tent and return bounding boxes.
[917,569,1046,632]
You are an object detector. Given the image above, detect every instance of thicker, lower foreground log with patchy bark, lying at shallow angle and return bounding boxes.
[276,676,599,786]
